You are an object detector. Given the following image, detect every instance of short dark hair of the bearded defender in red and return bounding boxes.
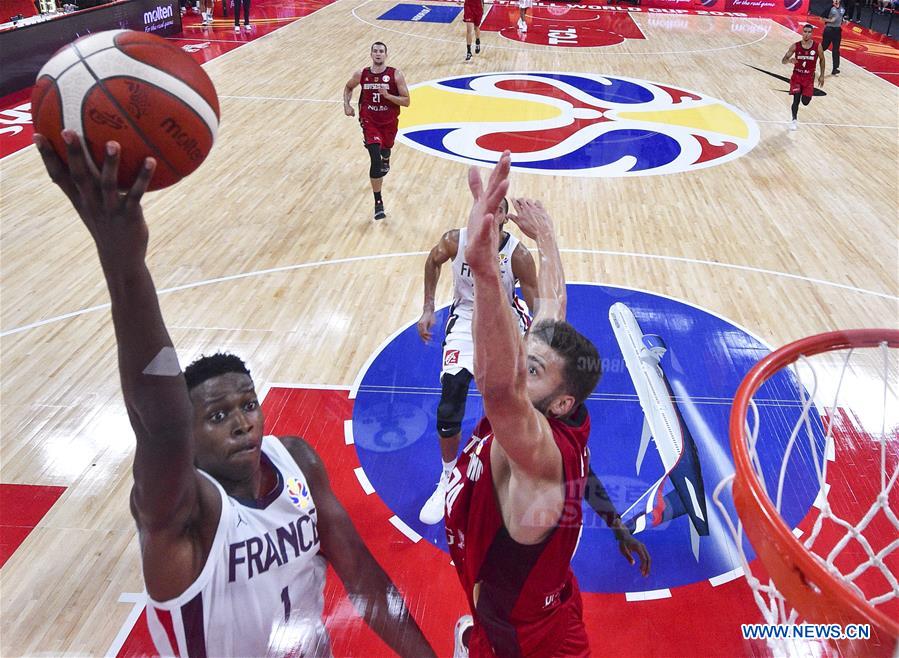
[530,320,602,405]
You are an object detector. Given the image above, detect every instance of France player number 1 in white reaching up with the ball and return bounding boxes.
[35,130,434,658]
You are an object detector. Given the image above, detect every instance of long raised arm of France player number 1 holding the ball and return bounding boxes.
[34,131,210,597]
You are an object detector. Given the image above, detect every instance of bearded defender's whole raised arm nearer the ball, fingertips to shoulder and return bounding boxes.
[465,152,562,480]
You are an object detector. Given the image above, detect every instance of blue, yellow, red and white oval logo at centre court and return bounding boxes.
[399,73,759,177]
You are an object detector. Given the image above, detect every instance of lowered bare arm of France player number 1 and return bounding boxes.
[282,437,435,658]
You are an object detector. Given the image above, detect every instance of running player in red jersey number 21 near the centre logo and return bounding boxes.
[343,41,409,219]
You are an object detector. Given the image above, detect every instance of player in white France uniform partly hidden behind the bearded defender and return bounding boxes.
[418,199,537,525]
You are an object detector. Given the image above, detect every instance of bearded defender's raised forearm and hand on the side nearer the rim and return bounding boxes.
[510,199,568,324]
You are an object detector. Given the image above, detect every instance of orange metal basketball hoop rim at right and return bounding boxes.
[730,329,899,638]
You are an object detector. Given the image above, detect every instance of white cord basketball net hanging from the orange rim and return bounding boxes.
[713,336,899,655]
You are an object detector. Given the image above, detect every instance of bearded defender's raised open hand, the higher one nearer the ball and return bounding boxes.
[465,151,512,272]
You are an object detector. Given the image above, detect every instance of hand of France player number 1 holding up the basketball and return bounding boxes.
[34,130,156,270]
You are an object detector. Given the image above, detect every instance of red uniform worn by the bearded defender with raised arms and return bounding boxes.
[445,406,590,658]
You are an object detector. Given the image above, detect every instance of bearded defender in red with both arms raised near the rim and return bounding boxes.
[445,151,640,658]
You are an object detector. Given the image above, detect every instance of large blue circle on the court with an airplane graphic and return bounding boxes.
[353,284,824,592]
